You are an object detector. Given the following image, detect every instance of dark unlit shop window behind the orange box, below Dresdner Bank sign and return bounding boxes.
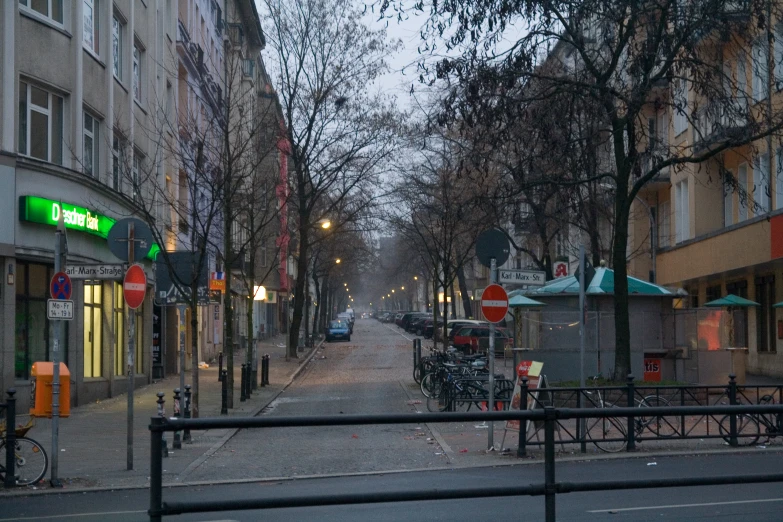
[14,262,69,379]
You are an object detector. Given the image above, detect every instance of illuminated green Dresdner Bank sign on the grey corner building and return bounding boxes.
[19,196,160,260]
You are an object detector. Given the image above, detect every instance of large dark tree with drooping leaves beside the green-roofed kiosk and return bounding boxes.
[381,0,783,378]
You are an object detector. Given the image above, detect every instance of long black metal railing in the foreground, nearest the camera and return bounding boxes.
[148,396,783,522]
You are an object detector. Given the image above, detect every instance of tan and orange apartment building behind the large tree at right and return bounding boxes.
[629,10,783,377]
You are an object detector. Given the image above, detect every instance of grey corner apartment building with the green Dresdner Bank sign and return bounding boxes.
[0,0,177,410]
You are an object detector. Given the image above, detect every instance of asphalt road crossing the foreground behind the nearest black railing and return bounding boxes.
[0,452,783,522]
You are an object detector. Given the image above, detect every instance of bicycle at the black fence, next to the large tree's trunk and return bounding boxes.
[585,375,677,453]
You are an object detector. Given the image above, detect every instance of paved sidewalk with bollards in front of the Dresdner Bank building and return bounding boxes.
[0,335,322,496]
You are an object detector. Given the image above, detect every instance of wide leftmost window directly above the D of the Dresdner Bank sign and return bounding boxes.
[19,82,63,165]
